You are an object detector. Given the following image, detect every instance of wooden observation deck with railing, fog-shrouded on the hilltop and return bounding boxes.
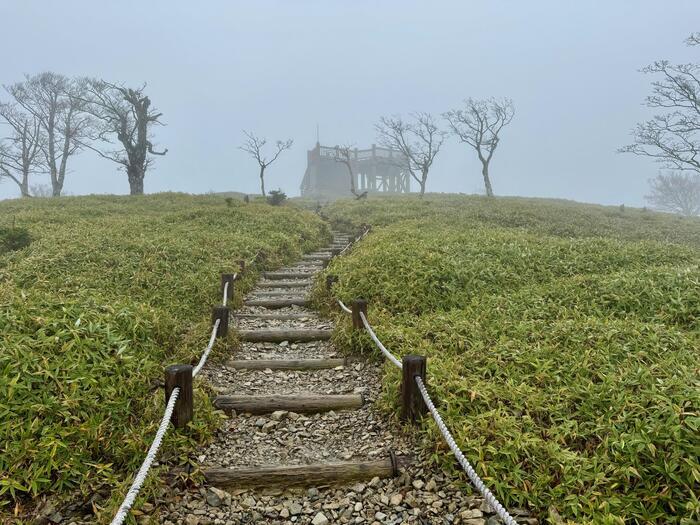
[301,142,411,199]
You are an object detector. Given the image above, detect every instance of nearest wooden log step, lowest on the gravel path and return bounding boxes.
[203,452,410,489]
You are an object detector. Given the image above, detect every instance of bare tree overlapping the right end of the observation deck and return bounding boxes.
[375,113,445,197]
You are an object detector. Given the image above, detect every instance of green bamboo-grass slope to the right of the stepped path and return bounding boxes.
[324,196,700,523]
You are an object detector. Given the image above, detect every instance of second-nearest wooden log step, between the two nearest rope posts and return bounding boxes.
[214,394,363,414]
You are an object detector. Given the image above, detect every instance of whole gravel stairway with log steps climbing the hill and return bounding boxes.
[161,232,536,525]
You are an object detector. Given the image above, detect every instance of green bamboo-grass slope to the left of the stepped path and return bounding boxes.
[0,194,330,510]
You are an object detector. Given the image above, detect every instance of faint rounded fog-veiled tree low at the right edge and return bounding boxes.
[645,171,700,217]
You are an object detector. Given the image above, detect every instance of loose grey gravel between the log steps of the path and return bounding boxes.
[159,237,537,525]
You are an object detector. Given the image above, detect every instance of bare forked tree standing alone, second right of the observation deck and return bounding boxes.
[443,98,515,197]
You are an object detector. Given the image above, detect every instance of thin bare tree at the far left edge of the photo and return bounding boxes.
[0,104,45,197]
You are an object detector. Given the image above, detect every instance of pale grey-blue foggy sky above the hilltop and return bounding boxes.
[0,0,700,205]
